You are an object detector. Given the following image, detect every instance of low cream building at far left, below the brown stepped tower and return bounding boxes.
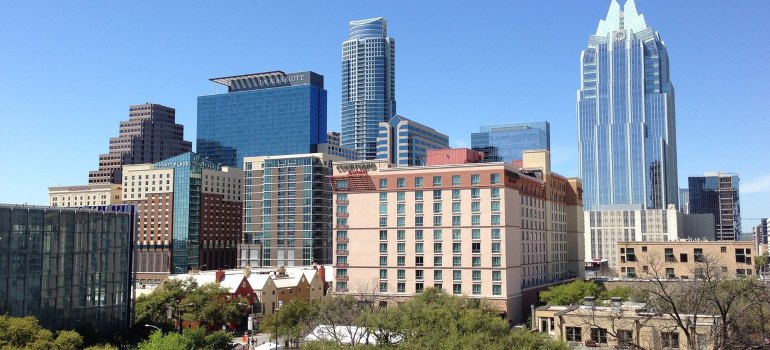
[48,183,123,208]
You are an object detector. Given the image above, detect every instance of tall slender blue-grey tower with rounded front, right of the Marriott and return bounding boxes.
[340,17,396,159]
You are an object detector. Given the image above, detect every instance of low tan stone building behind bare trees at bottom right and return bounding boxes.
[532,297,721,350]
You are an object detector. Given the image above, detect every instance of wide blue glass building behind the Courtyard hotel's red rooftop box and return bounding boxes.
[471,122,551,163]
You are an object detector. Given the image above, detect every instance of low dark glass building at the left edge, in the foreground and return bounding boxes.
[0,204,133,336]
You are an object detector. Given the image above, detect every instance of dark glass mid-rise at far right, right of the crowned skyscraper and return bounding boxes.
[688,173,741,241]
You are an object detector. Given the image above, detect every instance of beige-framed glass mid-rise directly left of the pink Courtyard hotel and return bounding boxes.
[238,153,344,267]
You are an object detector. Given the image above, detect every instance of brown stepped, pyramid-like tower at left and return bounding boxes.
[88,103,192,184]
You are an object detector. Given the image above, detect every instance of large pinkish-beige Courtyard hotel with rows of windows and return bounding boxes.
[331,151,584,322]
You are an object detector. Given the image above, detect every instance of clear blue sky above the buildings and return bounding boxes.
[0,0,770,232]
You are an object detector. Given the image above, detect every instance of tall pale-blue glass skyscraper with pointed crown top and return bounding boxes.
[577,0,678,210]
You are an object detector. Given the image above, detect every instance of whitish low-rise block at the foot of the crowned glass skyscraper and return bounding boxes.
[583,205,714,268]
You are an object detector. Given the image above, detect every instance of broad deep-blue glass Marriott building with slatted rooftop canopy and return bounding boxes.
[197,71,326,168]
